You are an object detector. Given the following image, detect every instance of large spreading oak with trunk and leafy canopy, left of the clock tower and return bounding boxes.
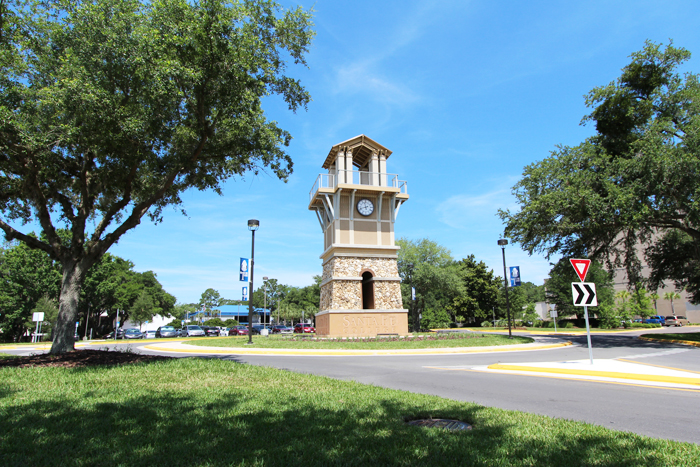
[0,0,313,354]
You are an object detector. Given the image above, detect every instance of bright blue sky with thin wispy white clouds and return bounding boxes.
[94,0,700,303]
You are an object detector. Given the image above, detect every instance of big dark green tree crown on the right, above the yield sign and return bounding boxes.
[500,42,700,302]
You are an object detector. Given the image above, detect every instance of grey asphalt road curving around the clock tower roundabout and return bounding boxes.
[5,328,700,444]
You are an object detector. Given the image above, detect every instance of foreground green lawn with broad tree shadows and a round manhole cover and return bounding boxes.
[0,358,700,467]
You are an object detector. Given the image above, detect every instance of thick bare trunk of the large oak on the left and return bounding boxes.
[50,261,88,355]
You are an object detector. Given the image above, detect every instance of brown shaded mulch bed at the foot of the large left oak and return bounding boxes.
[0,350,174,368]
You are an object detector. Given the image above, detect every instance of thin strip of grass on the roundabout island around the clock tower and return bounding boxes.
[187,333,533,350]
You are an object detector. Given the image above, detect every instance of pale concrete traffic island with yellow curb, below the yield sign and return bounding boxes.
[471,359,700,391]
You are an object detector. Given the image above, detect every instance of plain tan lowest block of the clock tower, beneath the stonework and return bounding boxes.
[316,309,408,337]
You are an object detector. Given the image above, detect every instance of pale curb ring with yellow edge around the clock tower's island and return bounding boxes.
[143,342,572,357]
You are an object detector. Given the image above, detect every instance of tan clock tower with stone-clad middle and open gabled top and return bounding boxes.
[309,135,408,337]
